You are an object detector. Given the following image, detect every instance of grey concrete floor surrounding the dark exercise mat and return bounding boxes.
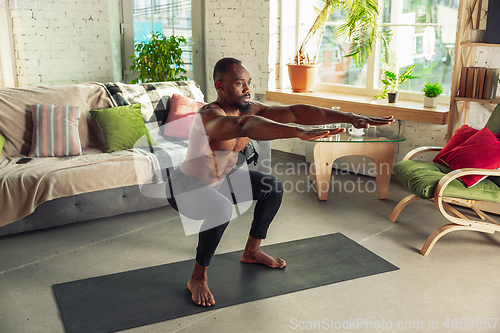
[0,157,500,333]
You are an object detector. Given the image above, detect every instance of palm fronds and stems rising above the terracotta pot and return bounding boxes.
[291,0,391,67]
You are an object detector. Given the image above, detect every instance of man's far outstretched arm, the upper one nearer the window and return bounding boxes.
[255,103,394,128]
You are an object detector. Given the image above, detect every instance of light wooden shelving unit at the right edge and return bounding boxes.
[447,0,500,140]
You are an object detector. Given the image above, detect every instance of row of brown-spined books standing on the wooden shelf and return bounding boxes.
[458,67,500,99]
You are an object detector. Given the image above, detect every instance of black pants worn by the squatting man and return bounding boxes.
[167,169,283,266]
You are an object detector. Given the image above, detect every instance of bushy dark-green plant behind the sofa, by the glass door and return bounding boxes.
[129,33,187,83]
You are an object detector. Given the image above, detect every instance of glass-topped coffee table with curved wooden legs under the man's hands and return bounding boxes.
[309,126,406,200]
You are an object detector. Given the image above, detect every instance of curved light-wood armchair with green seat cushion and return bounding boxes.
[389,105,500,255]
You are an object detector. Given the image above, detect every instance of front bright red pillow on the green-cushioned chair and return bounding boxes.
[441,127,500,187]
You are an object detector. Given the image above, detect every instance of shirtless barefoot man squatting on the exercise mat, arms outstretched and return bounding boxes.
[169,58,394,306]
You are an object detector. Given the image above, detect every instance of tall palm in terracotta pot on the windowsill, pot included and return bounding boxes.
[287,0,391,92]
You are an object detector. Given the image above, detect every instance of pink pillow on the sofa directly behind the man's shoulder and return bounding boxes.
[164,94,206,139]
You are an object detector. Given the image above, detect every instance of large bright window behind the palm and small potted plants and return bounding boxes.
[301,0,459,102]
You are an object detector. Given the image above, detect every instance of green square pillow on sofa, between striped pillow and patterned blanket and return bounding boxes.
[90,103,157,153]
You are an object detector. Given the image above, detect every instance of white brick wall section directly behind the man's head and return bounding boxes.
[205,0,277,101]
